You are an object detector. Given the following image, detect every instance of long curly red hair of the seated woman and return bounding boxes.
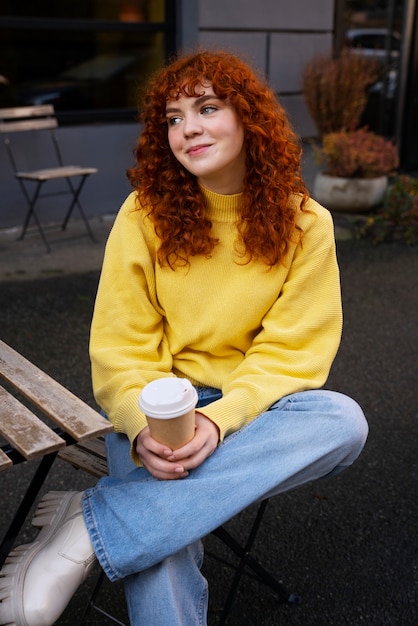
[127,51,308,267]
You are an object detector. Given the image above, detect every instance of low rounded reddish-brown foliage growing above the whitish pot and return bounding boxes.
[314,128,399,178]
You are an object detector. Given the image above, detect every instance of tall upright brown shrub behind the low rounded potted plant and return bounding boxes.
[303,49,381,136]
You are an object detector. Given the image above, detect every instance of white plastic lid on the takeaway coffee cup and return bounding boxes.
[139,378,198,419]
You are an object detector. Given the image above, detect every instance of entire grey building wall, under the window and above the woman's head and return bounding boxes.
[0,0,334,228]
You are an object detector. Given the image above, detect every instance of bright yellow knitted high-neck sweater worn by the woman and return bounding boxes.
[90,183,342,462]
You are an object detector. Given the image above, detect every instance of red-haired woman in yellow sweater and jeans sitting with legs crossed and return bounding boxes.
[0,52,367,626]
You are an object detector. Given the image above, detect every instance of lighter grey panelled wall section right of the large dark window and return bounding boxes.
[199,0,334,137]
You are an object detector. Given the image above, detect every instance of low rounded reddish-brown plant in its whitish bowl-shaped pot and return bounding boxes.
[312,128,399,212]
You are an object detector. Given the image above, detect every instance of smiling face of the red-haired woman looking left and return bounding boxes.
[166,85,245,194]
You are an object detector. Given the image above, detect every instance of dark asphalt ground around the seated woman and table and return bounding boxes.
[0,196,418,626]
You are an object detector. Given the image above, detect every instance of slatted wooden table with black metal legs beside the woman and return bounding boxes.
[0,340,113,567]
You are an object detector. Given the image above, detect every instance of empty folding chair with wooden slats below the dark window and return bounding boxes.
[0,105,98,252]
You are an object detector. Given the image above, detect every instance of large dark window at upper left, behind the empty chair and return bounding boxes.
[0,0,175,123]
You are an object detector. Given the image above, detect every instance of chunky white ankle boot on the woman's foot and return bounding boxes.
[0,491,96,626]
